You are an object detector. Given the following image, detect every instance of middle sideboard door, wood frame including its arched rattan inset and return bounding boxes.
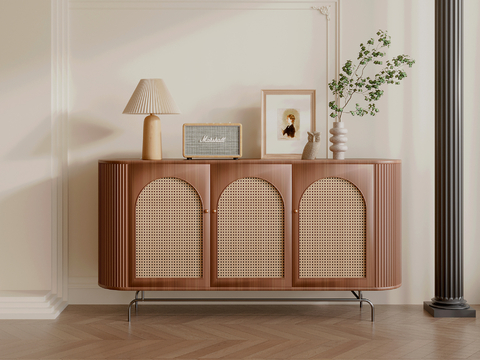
[211,164,291,289]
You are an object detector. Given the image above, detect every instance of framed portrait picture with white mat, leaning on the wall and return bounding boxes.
[262,90,315,159]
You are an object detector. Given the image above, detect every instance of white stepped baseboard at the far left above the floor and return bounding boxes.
[0,290,67,320]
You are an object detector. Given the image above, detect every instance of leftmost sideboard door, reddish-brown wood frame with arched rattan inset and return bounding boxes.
[129,163,210,290]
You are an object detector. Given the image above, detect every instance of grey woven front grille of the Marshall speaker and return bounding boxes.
[184,125,240,156]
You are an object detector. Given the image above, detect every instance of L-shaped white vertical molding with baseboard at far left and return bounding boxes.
[0,0,68,319]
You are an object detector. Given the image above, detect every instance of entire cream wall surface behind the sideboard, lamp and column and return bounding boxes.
[0,0,480,304]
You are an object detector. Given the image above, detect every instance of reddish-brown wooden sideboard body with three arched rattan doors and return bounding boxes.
[98,159,401,291]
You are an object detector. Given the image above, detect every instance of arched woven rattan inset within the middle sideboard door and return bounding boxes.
[217,177,284,278]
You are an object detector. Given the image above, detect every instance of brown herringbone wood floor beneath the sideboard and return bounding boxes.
[0,305,480,360]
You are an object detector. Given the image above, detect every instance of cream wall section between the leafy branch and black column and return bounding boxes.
[341,0,436,304]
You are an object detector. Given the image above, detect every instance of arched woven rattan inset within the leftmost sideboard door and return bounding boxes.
[135,177,203,278]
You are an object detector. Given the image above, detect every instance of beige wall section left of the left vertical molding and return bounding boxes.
[0,0,52,291]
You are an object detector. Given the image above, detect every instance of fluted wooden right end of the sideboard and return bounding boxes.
[374,163,402,288]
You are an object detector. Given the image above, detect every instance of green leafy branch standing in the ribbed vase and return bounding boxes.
[328,30,415,121]
